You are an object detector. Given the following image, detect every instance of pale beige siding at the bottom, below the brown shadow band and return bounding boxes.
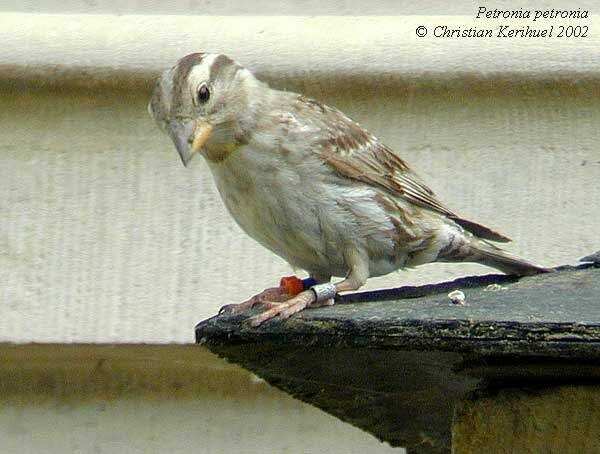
[0,393,402,454]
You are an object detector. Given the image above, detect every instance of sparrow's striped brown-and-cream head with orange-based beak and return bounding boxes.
[148,53,262,166]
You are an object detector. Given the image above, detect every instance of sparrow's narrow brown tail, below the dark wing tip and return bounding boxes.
[468,239,553,276]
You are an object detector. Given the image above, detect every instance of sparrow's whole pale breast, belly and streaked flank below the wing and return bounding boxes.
[204,146,428,276]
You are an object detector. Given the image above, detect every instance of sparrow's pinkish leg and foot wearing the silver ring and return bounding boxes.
[248,263,369,326]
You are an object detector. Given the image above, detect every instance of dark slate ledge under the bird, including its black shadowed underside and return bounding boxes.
[196,264,600,452]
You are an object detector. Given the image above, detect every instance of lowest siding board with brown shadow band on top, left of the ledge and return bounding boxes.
[0,345,402,454]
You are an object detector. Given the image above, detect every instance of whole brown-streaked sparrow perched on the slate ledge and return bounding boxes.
[148,53,550,326]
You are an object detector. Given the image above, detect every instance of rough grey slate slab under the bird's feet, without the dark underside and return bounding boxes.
[197,266,600,359]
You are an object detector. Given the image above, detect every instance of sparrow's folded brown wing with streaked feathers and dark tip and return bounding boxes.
[297,96,510,242]
